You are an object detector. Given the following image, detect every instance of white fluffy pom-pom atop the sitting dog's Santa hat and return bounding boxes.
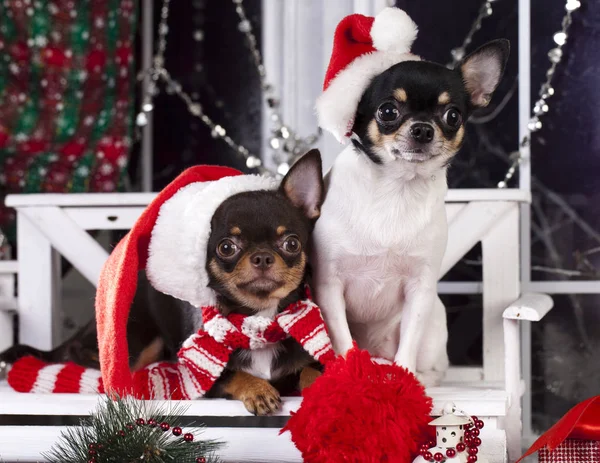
[371,8,419,53]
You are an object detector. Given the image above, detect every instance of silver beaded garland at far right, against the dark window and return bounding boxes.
[498,0,581,188]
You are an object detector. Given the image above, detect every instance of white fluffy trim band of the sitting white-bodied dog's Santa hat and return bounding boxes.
[316,51,420,143]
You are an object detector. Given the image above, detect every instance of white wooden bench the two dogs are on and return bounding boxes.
[0,189,552,463]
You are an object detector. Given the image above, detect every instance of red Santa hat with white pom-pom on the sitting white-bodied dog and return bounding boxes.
[316,8,419,143]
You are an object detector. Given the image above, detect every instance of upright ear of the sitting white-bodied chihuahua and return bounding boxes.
[460,39,510,108]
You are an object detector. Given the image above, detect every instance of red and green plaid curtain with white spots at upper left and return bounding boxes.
[0,0,137,237]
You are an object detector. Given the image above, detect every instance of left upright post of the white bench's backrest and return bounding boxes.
[17,211,62,350]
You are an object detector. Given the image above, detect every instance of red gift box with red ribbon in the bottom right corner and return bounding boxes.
[517,396,600,463]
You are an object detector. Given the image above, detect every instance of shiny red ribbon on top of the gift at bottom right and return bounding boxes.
[517,396,600,463]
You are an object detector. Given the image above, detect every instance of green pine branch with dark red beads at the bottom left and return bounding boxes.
[43,397,222,463]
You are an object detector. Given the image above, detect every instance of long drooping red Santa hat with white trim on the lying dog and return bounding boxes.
[96,166,277,392]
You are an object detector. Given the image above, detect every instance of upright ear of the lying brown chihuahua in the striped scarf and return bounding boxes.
[279,149,325,220]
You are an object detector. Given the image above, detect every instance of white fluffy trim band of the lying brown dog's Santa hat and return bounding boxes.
[146,175,277,307]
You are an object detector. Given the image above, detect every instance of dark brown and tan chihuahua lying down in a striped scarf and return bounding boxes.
[0,150,324,415]
